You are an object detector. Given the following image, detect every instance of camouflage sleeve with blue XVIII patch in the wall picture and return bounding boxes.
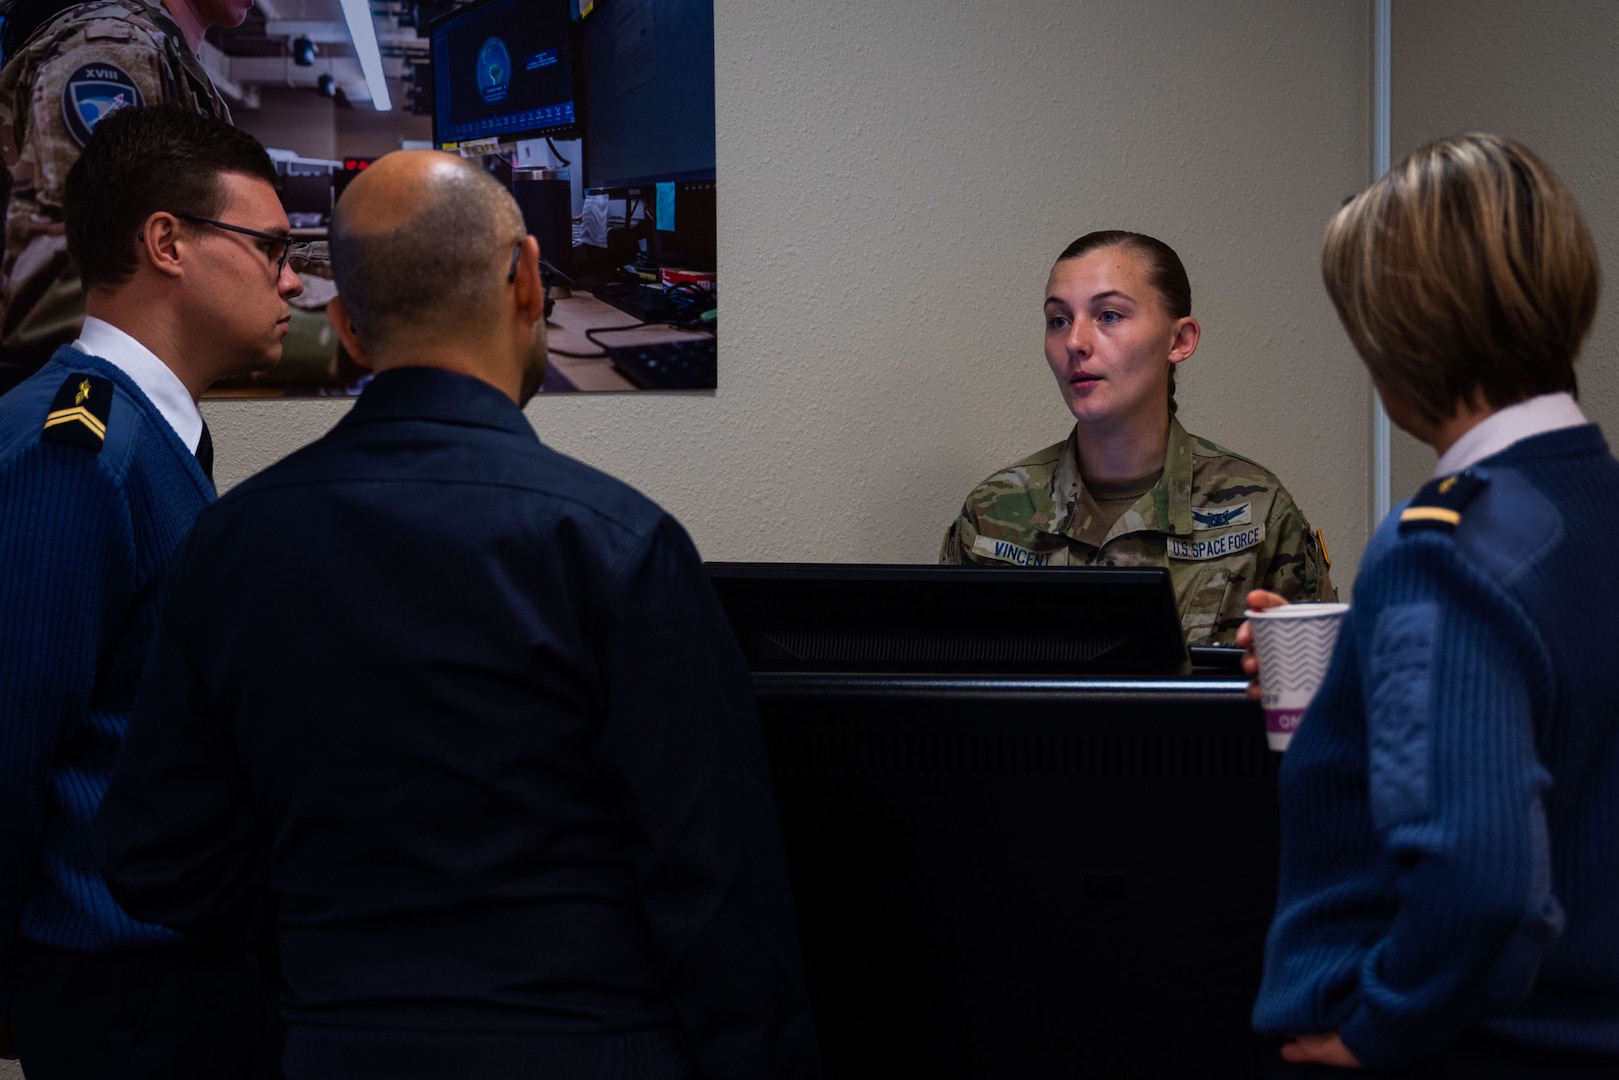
[3,18,164,350]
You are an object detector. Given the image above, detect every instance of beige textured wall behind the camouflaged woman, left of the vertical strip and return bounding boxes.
[206,0,1370,585]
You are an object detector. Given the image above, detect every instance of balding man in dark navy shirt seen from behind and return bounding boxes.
[96,151,818,1080]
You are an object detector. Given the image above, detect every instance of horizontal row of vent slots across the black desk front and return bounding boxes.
[772,729,1279,777]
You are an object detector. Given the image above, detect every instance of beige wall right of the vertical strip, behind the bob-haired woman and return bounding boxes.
[1391,0,1619,500]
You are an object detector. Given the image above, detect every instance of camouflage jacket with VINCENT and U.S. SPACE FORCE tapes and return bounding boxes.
[939,419,1336,644]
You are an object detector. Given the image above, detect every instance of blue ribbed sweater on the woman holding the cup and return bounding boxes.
[1255,426,1619,1067]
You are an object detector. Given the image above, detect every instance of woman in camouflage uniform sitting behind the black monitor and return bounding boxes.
[939,232,1336,644]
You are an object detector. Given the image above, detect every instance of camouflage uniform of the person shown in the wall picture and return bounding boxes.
[0,0,230,361]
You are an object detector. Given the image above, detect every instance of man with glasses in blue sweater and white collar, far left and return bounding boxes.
[0,107,301,1080]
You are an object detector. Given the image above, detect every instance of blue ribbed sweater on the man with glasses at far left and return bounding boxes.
[0,348,214,1015]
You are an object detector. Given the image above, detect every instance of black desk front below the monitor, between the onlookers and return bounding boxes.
[756,674,1279,1080]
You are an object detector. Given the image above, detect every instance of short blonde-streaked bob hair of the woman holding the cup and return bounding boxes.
[1321,134,1601,424]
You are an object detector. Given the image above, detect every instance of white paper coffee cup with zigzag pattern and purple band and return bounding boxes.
[1247,604,1349,750]
